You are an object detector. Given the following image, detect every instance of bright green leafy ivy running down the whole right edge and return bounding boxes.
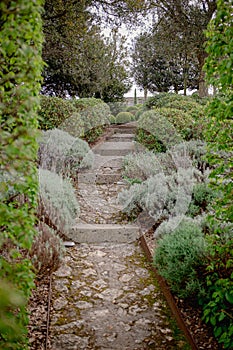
[201,0,233,349]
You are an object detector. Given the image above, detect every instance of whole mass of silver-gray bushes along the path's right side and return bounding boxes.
[118,140,207,228]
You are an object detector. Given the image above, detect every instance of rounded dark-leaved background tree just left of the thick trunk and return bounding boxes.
[132,25,198,98]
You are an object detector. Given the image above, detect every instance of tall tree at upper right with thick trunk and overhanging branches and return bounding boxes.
[133,0,216,97]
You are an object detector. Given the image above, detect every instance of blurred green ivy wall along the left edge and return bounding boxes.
[0,0,42,349]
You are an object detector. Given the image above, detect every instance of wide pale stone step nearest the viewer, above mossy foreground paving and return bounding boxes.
[69,224,140,243]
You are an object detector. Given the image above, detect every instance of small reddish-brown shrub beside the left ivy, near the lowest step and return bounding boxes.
[29,222,65,278]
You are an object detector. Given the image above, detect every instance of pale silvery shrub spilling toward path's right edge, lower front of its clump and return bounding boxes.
[118,168,194,222]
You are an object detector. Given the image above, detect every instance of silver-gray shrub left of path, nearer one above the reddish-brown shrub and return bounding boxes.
[38,168,79,236]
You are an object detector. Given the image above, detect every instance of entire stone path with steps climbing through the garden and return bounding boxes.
[50,129,188,350]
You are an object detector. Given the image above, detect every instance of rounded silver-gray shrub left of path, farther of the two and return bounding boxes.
[38,129,93,176]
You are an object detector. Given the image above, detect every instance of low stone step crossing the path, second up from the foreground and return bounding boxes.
[78,173,122,185]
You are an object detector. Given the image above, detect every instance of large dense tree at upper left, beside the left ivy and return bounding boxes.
[43,0,149,101]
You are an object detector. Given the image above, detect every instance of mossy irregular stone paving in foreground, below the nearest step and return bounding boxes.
[50,244,187,350]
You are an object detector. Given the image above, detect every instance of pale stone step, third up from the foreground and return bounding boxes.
[92,142,135,157]
